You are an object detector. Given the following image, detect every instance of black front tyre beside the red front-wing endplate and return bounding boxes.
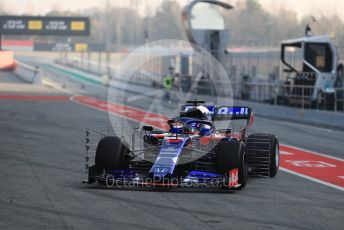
[216,140,248,190]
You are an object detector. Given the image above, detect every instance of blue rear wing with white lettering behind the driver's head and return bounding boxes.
[181,104,252,122]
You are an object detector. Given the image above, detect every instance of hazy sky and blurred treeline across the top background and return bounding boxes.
[0,0,344,51]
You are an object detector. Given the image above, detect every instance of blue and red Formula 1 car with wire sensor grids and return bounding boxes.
[86,100,279,190]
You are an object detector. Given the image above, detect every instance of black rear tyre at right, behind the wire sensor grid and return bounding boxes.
[246,133,280,177]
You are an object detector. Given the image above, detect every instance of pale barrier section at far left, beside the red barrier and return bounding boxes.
[14,62,43,85]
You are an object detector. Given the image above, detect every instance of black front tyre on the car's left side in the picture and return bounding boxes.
[95,136,129,171]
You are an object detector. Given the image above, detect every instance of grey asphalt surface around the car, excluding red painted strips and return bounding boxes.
[0,63,344,229]
